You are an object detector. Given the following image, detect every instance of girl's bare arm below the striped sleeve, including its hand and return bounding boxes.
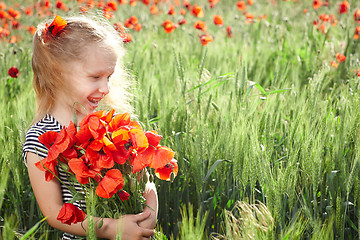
[26,152,154,240]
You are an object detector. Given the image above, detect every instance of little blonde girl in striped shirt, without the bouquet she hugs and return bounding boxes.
[23,16,158,240]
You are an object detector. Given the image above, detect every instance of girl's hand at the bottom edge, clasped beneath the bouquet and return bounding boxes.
[114,212,155,240]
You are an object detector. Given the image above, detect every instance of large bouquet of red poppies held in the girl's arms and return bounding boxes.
[36,109,178,224]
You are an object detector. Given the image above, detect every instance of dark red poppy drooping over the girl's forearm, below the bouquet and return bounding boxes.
[56,203,86,225]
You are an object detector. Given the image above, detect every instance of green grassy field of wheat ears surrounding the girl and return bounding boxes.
[0,0,360,239]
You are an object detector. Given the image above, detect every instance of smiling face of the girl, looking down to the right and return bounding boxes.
[57,45,117,120]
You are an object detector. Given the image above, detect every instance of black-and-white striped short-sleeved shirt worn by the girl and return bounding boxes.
[22,114,86,240]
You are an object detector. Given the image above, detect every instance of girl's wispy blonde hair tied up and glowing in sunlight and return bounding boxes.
[31,16,133,122]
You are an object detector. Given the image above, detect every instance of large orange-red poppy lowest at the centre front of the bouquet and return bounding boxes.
[96,169,124,198]
